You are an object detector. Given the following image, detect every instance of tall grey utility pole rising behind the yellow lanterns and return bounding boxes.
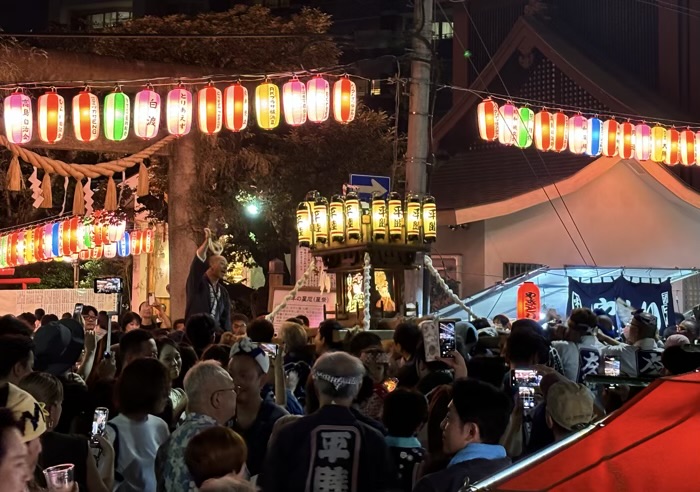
[404,0,432,314]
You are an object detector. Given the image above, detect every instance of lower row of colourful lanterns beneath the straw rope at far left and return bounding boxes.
[0,213,155,268]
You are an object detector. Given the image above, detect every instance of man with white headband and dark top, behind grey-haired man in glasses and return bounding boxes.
[228,337,288,476]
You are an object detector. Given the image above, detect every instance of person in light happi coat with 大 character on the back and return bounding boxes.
[552,308,603,383]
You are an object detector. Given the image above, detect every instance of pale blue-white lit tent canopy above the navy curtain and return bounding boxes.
[438,267,698,319]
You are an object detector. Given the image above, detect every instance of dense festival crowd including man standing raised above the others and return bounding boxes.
[0,235,700,492]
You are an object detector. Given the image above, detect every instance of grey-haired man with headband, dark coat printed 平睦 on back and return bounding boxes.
[258,352,397,492]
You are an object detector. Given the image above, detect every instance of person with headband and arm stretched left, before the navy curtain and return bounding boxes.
[598,310,664,378]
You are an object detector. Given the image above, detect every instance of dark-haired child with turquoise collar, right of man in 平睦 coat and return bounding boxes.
[383,388,428,492]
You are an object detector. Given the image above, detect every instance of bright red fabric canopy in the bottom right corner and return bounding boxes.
[469,372,700,492]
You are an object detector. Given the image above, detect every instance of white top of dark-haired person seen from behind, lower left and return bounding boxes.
[105,415,170,492]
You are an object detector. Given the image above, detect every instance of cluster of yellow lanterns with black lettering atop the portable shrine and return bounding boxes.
[296,191,437,248]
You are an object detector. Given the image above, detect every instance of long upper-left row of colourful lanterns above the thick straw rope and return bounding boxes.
[4,75,357,144]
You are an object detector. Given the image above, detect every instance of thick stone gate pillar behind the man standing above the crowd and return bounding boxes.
[168,135,196,320]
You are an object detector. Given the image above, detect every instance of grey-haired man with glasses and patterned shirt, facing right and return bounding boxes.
[156,360,236,492]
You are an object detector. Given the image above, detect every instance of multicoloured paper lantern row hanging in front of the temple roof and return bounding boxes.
[477,99,700,166]
